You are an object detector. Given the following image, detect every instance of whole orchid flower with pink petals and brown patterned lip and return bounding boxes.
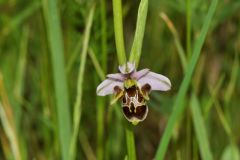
[97,62,171,124]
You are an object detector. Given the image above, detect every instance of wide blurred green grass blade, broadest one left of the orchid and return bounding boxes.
[42,0,72,160]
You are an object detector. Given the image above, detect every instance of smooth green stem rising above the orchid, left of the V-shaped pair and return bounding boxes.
[113,0,126,65]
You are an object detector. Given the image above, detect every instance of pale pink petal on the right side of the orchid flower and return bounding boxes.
[138,72,171,91]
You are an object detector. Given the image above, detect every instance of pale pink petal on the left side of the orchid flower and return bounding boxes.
[97,79,123,96]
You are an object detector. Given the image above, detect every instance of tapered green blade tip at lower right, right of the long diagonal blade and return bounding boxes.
[191,94,213,160]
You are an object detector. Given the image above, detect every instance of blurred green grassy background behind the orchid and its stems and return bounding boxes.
[0,0,240,160]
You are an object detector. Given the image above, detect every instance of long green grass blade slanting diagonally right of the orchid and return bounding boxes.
[155,0,218,160]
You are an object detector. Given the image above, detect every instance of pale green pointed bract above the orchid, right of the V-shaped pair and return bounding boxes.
[129,0,148,66]
